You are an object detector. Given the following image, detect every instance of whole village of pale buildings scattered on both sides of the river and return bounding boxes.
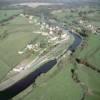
[8,10,97,76]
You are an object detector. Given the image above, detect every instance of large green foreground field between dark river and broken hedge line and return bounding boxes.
[14,56,82,100]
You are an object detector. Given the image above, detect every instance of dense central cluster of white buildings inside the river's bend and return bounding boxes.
[40,22,68,43]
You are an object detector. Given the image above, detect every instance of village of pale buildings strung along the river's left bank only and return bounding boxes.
[7,14,70,77]
